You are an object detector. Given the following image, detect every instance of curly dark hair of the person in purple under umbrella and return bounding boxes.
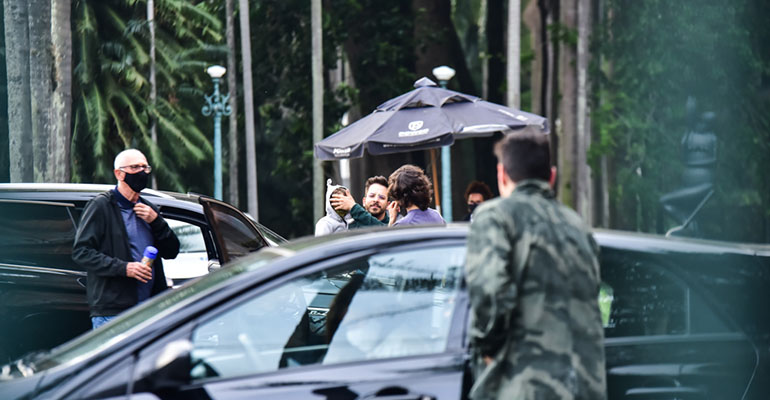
[388,164,433,211]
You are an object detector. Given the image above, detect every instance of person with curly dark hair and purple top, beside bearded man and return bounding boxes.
[388,164,446,226]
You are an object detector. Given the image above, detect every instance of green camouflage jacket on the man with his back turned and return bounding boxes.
[466,180,606,400]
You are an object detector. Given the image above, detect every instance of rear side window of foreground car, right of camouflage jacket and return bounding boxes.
[599,256,729,338]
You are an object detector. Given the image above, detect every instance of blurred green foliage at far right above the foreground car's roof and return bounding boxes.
[590,0,770,241]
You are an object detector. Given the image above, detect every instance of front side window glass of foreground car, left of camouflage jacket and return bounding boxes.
[190,246,465,380]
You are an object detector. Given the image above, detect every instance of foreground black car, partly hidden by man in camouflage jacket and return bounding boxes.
[0,226,770,399]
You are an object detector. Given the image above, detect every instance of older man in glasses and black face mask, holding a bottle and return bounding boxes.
[72,149,179,329]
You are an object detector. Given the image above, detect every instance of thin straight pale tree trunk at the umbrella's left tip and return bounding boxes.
[310,0,325,221]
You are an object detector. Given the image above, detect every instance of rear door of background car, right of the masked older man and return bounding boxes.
[199,196,268,265]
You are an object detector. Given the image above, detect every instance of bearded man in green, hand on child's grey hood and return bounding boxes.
[330,176,390,228]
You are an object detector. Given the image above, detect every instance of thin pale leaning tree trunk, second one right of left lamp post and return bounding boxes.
[233,0,258,221]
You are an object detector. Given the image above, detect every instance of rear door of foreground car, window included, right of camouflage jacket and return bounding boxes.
[599,248,757,399]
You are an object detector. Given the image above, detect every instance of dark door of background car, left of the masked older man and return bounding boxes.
[0,199,90,361]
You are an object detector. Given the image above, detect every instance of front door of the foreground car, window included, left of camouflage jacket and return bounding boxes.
[133,242,467,399]
